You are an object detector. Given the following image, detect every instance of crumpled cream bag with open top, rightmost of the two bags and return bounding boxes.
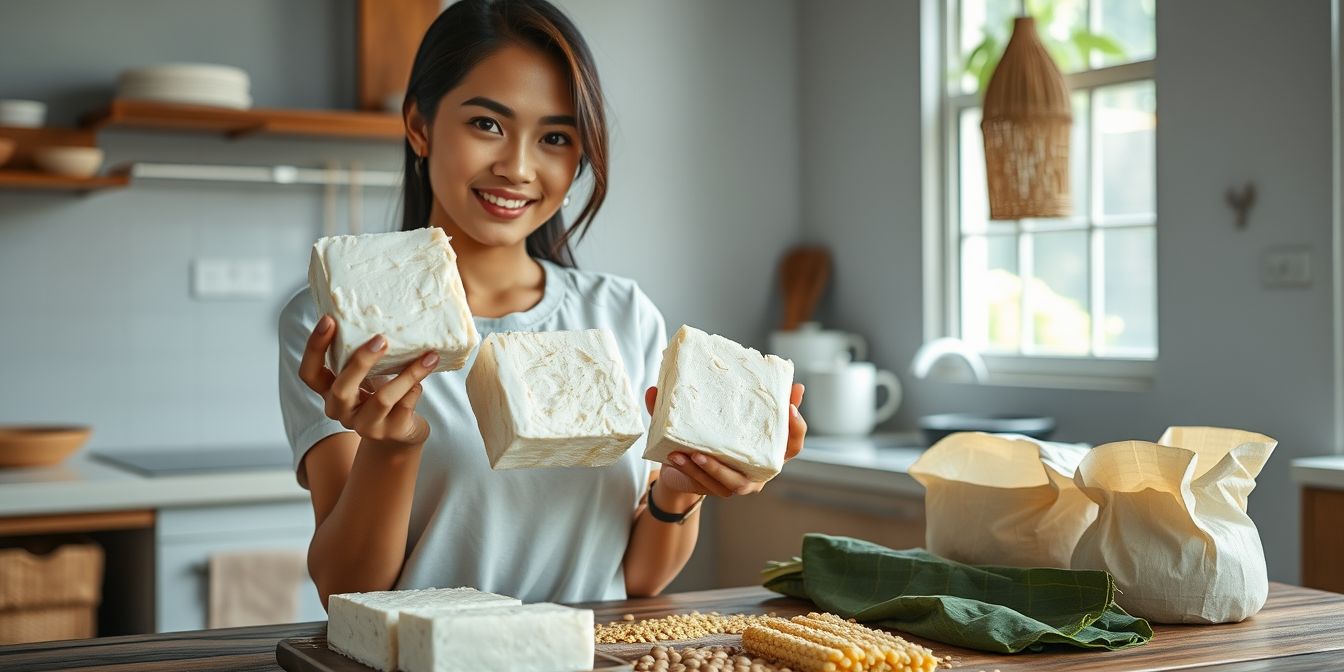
[1073,427,1278,624]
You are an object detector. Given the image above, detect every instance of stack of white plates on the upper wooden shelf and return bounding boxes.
[117,63,251,110]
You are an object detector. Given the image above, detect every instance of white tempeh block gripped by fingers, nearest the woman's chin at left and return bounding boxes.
[308,227,480,375]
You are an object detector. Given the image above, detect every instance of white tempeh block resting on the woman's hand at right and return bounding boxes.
[644,325,793,482]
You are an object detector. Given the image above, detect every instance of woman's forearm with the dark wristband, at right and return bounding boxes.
[621,487,702,597]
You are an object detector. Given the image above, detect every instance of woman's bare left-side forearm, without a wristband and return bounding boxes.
[308,441,423,605]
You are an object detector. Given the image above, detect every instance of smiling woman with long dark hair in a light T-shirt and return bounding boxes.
[271,0,805,603]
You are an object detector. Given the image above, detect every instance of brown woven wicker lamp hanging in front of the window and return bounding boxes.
[980,16,1074,219]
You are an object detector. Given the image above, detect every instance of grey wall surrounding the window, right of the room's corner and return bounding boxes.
[800,0,1335,582]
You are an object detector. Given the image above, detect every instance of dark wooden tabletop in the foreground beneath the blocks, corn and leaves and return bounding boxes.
[0,583,1344,672]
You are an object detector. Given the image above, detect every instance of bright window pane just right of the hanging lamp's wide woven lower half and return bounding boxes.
[1095,79,1157,216]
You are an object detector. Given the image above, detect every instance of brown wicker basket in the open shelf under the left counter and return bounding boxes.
[0,540,103,644]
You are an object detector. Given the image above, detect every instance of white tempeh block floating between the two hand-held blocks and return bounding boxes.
[466,329,644,469]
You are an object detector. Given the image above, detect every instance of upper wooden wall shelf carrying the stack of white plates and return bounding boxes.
[81,101,406,140]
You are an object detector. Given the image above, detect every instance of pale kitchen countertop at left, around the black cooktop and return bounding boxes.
[0,453,308,517]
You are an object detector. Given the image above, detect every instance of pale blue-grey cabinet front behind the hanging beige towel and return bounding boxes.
[155,501,327,632]
